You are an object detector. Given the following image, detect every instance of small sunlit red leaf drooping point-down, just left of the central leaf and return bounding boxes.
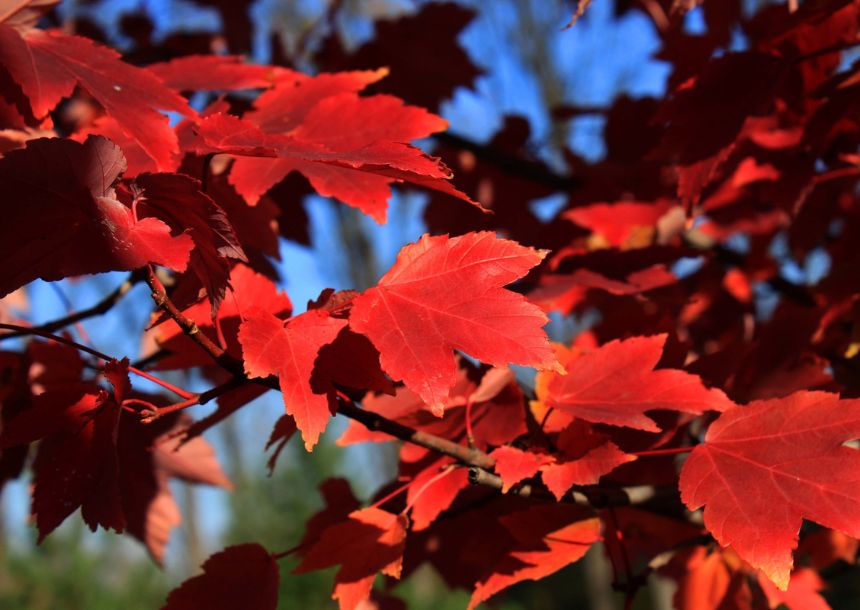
[239,308,347,451]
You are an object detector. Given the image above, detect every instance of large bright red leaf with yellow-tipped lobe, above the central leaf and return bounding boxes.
[184,70,478,223]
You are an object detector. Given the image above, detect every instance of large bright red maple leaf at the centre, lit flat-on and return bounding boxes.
[349,233,557,413]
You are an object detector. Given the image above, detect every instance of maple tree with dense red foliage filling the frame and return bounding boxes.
[0,0,860,610]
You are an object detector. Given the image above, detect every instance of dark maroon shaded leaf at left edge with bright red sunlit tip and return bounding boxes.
[0,136,194,296]
